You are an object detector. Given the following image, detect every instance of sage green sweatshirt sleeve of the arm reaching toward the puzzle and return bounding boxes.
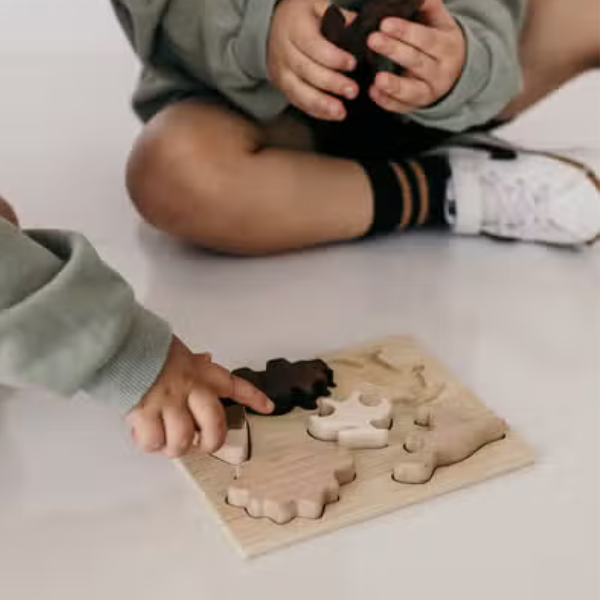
[0,218,171,411]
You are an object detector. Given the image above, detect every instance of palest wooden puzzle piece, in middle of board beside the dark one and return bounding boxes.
[308,392,393,448]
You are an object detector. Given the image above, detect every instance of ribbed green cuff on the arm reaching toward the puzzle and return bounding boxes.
[84,305,172,412]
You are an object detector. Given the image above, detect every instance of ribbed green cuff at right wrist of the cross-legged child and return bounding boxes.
[411,17,492,132]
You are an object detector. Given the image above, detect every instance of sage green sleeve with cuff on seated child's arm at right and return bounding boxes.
[411,0,526,132]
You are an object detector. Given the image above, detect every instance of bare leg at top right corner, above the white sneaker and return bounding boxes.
[502,0,600,118]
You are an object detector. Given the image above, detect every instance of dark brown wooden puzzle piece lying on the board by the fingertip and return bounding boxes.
[233,358,335,416]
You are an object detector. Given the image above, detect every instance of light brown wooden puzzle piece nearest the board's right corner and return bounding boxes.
[394,405,508,483]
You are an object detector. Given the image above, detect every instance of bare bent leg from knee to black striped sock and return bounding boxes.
[128,102,373,254]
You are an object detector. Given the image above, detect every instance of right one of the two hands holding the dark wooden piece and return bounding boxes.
[368,0,467,114]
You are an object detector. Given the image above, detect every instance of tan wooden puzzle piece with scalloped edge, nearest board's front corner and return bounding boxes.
[227,446,356,524]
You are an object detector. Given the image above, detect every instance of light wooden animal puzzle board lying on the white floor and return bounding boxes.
[177,337,533,556]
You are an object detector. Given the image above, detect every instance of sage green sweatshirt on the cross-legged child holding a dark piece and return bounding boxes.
[112,0,526,132]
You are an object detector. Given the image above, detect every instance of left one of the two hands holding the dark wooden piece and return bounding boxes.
[268,0,358,120]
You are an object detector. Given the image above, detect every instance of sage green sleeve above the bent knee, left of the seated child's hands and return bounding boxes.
[112,0,287,119]
